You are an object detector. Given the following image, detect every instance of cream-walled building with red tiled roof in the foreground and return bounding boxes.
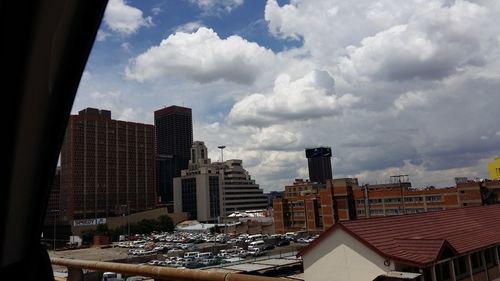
[298,204,500,281]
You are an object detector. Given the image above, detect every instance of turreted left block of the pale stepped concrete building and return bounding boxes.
[174,141,224,222]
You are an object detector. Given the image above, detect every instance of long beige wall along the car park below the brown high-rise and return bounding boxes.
[71,208,187,235]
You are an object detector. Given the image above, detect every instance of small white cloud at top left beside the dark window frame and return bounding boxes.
[104,0,153,35]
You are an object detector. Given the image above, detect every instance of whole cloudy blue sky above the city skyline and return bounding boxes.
[72,0,500,191]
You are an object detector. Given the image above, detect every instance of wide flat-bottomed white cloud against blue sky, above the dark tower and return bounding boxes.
[125,27,275,84]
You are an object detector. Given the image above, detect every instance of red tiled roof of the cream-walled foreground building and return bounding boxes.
[298,205,500,266]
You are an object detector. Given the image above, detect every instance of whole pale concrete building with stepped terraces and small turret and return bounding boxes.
[174,141,267,222]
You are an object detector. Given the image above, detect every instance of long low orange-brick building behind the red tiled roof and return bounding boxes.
[273,176,500,233]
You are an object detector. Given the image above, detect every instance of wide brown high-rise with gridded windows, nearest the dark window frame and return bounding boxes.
[60,108,156,219]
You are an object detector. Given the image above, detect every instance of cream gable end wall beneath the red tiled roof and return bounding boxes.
[303,229,394,281]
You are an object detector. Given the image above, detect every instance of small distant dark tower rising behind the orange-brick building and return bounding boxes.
[306,147,332,184]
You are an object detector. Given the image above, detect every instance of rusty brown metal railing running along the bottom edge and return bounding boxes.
[50,258,283,281]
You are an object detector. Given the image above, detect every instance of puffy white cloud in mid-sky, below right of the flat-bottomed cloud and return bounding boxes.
[228,70,359,126]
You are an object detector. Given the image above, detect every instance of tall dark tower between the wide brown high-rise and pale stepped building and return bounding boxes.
[155,105,193,203]
